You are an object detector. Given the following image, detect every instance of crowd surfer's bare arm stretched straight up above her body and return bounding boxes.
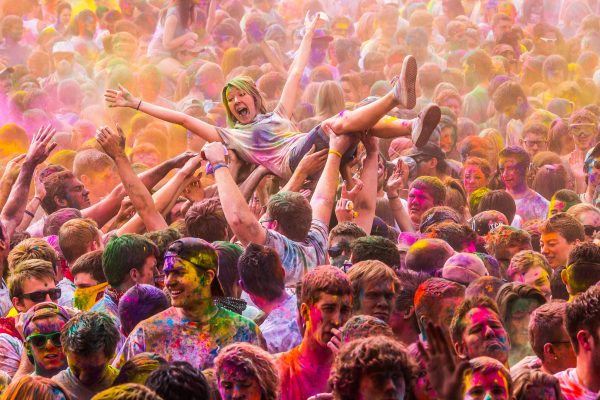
[275,13,319,118]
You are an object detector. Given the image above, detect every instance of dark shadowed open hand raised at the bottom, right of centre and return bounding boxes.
[417,323,469,400]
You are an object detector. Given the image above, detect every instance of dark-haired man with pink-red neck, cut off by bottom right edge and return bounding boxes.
[555,286,600,400]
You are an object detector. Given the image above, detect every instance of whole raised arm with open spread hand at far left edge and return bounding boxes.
[0,125,56,238]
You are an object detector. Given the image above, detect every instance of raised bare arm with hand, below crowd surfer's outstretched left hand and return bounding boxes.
[96,126,167,232]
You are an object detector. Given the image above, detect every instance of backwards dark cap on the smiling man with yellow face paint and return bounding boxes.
[165,238,225,297]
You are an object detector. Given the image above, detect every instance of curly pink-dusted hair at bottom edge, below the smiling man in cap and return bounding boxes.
[215,343,279,400]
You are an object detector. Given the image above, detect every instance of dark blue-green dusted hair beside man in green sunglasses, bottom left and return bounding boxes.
[60,311,120,358]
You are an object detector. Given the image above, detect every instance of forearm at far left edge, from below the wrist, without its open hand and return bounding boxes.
[0,161,36,237]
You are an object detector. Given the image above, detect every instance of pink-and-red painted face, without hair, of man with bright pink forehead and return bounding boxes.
[457,307,510,364]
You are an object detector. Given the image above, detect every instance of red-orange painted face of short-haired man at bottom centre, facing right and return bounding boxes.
[302,293,352,348]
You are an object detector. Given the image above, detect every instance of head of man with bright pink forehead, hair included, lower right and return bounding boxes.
[450,296,510,366]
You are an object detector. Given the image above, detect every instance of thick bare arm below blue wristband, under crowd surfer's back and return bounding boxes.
[215,168,266,246]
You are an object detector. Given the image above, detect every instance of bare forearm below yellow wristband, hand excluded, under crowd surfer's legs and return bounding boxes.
[310,150,342,225]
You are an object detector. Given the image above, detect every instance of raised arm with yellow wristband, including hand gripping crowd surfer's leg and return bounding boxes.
[310,128,357,225]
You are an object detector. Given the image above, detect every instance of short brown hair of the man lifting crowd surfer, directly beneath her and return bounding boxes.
[267,192,312,242]
